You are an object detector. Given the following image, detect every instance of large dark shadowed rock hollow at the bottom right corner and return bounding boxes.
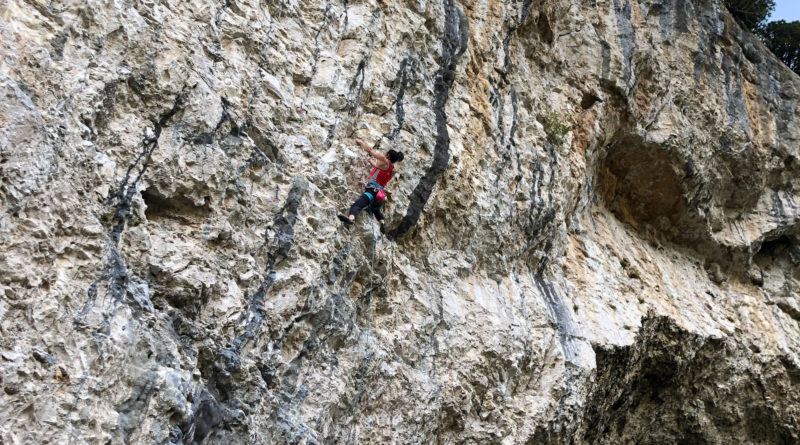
[577,317,800,444]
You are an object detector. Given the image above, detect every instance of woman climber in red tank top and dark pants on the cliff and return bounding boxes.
[339,139,403,233]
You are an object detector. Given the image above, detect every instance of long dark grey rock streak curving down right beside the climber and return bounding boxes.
[388,0,469,239]
